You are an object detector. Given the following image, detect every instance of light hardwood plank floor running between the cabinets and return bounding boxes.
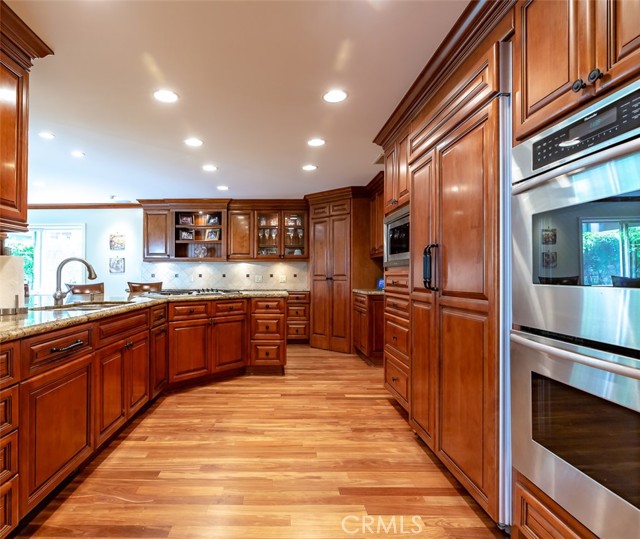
[17,345,503,539]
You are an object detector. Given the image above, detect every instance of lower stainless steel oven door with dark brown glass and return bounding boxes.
[511,331,640,539]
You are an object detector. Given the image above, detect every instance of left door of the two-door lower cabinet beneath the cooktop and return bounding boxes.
[169,319,211,383]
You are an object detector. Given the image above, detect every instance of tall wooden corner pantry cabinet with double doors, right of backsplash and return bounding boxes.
[306,188,382,353]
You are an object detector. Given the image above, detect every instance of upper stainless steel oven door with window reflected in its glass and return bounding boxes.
[512,139,640,349]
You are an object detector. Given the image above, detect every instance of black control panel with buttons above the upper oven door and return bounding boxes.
[532,89,640,170]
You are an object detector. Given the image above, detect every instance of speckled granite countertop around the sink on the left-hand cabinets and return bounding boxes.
[0,290,288,343]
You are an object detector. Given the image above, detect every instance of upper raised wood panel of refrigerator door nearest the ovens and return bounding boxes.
[436,103,498,300]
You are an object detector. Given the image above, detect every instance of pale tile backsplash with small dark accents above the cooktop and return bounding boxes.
[141,261,309,290]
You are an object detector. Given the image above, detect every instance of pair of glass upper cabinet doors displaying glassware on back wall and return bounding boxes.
[255,210,308,259]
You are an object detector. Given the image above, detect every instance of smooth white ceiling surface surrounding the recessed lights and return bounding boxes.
[7,0,467,203]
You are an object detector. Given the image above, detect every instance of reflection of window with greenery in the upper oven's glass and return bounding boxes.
[582,220,640,286]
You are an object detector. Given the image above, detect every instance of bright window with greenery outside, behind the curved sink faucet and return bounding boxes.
[5,225,85,294]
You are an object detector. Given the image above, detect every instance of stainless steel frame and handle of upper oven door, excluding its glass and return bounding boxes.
[511,143,640,349]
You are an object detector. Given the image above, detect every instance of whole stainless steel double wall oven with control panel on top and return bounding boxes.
[510,81,640,539]
